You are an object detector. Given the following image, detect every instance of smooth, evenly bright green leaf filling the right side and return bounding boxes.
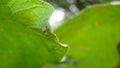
[56,4,120,68]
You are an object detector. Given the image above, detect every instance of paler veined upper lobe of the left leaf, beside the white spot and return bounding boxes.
[0,0,53,28]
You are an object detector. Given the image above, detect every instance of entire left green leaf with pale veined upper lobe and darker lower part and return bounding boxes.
[0,0,67,68]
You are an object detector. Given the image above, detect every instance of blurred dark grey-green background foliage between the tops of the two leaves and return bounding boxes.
[45,0,120,18]
